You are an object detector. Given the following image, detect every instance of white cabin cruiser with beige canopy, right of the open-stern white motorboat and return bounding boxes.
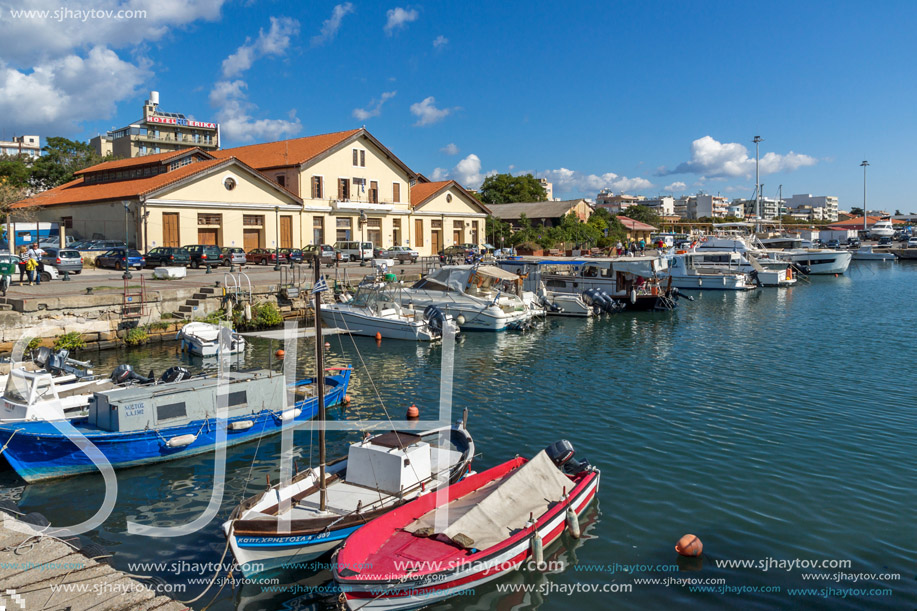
[399,265,537,331]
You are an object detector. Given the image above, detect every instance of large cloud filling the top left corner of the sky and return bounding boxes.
[0,0,225,68]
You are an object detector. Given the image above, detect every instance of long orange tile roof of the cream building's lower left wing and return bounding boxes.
[12,158,238,208]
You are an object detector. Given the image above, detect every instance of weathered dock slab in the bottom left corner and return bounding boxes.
[0,512,189,611]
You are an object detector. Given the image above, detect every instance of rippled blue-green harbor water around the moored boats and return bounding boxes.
[0,262,917,611]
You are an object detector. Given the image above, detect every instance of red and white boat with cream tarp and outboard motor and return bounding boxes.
[334,441,599,611]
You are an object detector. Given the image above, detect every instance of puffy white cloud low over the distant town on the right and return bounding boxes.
[658,136,817,178]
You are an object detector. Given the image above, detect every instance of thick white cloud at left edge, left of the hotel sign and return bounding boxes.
[0,46,150,133]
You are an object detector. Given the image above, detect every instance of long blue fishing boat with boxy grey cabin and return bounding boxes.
[0,367,351,482]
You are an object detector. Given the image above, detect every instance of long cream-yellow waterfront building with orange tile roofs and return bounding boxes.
[10,129,488,255]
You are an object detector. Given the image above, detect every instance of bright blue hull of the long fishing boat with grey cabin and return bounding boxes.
[0,370,350,483]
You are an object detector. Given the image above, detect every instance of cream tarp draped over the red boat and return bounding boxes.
[405,450,573,550]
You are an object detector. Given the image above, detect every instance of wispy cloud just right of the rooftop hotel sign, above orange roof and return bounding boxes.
[210,80,302,142]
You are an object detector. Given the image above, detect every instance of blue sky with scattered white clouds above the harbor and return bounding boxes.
[0,0,917,212]
